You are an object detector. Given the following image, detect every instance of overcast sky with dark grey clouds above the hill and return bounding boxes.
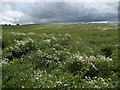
[0,1,118,24]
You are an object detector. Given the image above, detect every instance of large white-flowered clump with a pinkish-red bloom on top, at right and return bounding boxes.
[65,53,113,78]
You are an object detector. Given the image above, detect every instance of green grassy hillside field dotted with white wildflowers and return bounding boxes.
[1,23,120,88]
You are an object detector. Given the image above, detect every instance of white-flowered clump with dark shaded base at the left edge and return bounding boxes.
[3,38,35,60]
